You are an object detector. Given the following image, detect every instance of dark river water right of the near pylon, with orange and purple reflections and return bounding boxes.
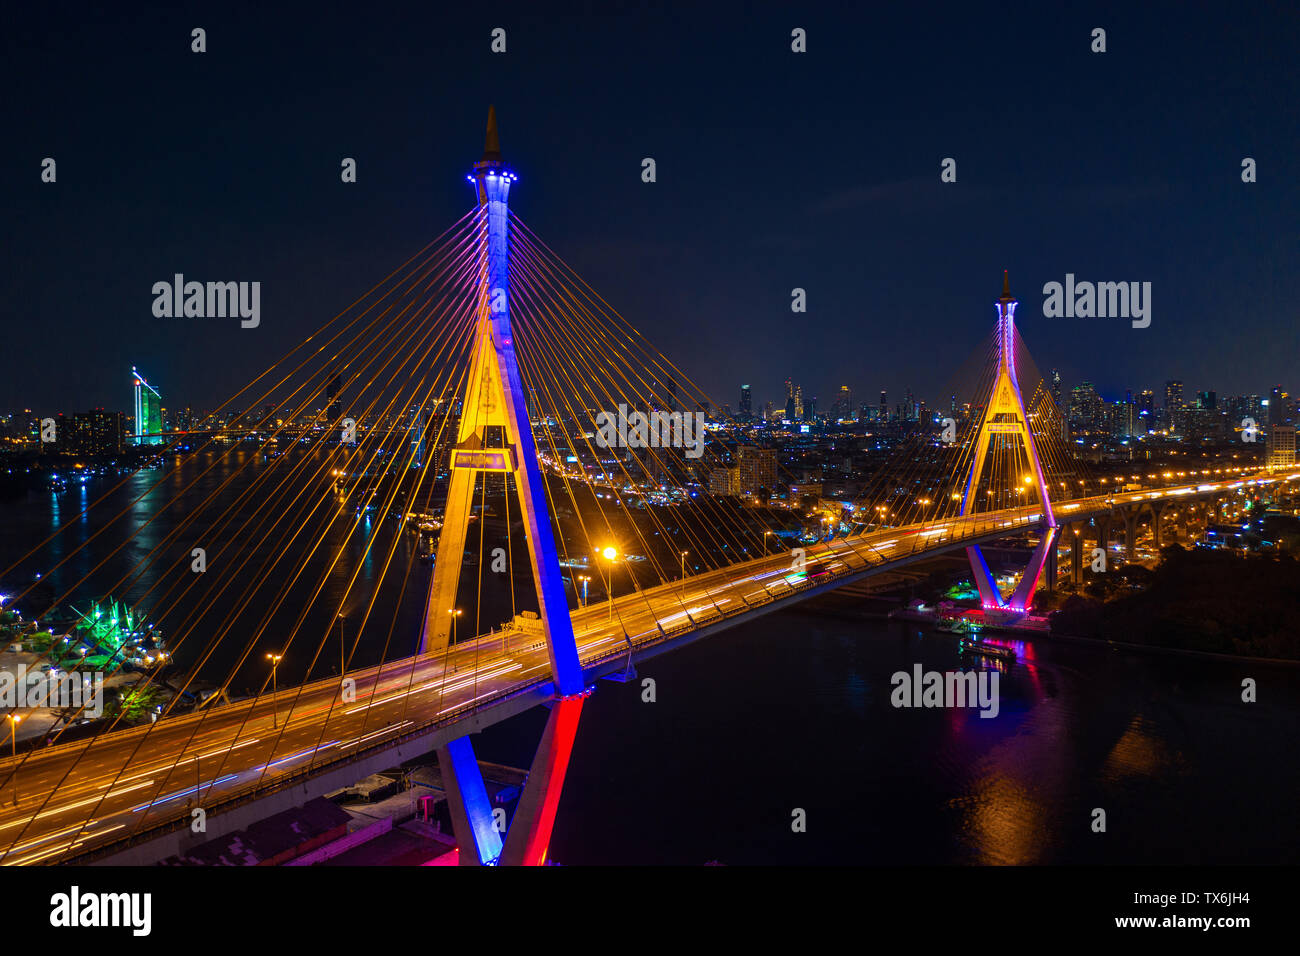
[478,606,1300,864]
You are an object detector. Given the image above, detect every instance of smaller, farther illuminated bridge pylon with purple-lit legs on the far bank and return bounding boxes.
[959,272,1057,610]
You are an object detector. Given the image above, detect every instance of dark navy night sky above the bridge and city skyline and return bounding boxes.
[0,0,1300,414]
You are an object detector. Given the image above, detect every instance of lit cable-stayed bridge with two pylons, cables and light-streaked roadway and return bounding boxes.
[0,111,1300,864]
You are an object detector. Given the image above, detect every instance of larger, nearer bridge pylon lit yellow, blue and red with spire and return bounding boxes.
[420,107,585,864]
